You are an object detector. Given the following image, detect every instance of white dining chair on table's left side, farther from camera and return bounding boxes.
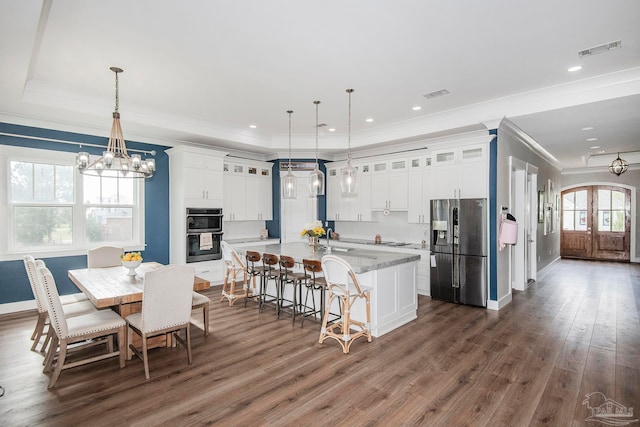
[22,255,96,353]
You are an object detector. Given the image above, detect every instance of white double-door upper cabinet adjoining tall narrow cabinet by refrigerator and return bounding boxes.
[371,159,409,211]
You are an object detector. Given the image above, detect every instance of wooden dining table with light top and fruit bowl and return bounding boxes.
[69,262,211,317]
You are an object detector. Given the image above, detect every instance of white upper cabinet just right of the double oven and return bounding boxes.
[224,159,273,221]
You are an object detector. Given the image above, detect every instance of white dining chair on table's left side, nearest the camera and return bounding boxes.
[38,267,127,388]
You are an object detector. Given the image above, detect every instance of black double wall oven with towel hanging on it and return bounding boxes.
[187,208,222,262]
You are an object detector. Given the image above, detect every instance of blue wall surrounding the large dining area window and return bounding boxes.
[0,123,169,304]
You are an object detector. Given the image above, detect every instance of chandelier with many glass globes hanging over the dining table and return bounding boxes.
[76,67,156,178]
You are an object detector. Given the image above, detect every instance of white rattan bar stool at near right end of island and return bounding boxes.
[318,255,371,353]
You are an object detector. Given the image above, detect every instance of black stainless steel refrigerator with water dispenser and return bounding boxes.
[430,199,488,307]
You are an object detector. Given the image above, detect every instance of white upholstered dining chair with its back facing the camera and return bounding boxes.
[126,265,195,379]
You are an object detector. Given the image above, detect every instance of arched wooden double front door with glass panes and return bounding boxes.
[560,185,631,262]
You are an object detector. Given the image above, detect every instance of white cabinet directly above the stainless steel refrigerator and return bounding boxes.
[431,144,489,199]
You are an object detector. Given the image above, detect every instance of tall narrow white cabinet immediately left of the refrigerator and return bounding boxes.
[407,154,431,224]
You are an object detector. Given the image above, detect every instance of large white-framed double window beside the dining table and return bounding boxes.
[0,145,144,259]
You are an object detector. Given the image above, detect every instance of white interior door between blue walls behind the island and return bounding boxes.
[279,171,318,243]
